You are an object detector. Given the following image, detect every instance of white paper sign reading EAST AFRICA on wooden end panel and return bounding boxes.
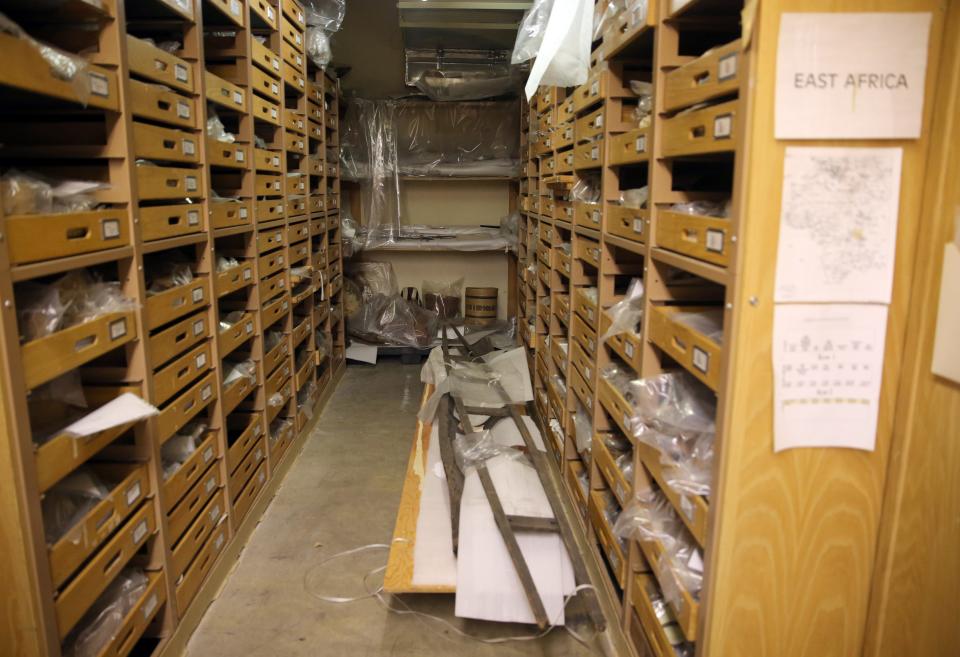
[775,12,930,139]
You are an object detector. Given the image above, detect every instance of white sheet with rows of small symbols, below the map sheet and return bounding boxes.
[773,304,887,452]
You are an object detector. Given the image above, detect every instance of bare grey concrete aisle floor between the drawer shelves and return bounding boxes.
[186,360,591,657]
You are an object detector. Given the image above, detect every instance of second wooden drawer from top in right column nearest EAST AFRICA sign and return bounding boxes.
[660,100,739,157]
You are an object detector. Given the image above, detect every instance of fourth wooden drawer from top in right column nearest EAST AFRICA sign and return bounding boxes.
[647,306,722,391]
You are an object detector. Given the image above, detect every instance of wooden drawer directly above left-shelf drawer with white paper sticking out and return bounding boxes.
[20,312,137,388]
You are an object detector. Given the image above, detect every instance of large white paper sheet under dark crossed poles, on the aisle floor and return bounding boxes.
[456,417,576,625]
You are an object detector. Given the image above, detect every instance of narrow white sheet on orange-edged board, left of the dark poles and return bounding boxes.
[412,424,457,586]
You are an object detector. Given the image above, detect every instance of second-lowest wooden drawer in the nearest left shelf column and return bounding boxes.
[55,504,157,640]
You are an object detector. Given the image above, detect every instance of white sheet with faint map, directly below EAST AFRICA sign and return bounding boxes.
[774,147,903,303]
